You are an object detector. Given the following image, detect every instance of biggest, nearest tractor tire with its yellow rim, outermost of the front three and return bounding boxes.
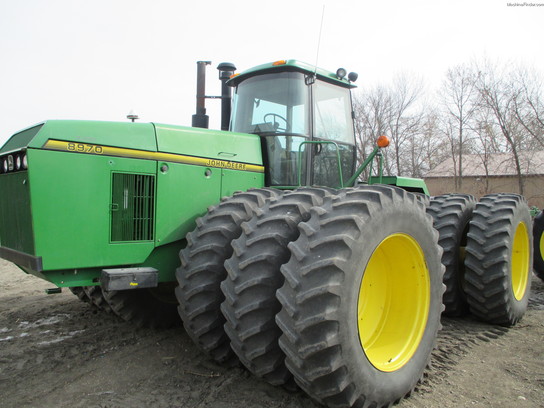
[276,186,444,408]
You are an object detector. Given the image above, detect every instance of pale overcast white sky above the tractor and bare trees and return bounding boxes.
[0,0,544,145]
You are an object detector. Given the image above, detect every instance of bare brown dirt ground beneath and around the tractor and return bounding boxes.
[0,260,544,408]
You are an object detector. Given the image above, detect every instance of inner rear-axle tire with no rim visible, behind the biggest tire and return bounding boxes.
[427,194,476,316]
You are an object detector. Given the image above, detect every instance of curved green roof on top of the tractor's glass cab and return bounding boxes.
[227,60,356,88]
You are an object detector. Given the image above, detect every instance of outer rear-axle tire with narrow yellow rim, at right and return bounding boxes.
[465,194,533,326]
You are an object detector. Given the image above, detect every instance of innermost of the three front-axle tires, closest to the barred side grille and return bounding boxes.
[176,189,281,363]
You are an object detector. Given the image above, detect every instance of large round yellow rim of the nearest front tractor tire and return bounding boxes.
[357,234,431,372]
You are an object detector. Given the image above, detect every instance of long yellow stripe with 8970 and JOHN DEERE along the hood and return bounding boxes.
[43,139,264,173]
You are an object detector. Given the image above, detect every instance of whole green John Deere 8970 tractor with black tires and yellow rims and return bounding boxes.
[0,60,532,407]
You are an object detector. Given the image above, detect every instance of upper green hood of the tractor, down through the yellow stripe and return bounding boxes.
[0,120,263,171]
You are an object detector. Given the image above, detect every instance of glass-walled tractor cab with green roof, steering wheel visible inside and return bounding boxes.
[228,60,356,188]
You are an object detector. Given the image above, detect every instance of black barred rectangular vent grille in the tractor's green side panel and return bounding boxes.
[111,173,155,242]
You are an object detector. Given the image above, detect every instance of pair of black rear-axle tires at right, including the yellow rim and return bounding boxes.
[427,194,536,326]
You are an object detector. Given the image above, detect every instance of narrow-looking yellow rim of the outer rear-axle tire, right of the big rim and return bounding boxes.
[511,222,528,300]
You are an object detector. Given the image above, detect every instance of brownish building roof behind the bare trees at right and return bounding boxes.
[425,151,544,178]
